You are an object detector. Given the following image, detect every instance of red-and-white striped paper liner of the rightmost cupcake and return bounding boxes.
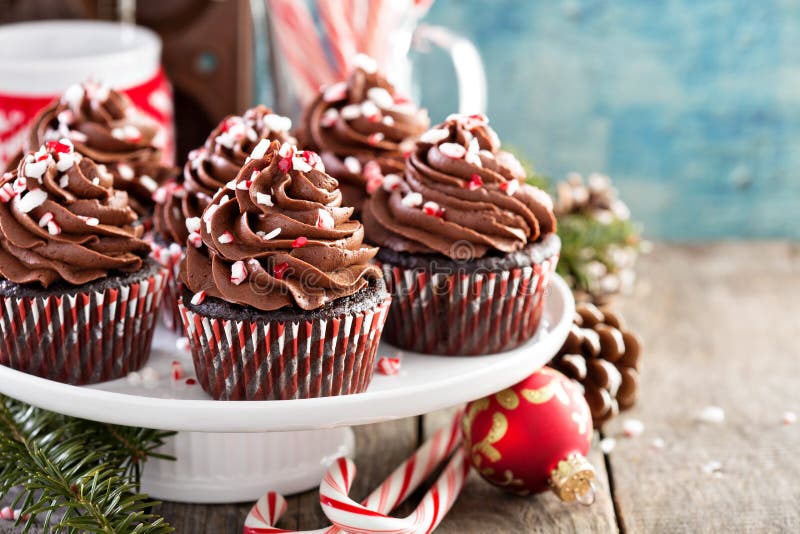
[379,254,558,356]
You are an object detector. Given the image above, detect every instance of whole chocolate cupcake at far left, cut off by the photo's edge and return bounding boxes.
[0,139,166,384]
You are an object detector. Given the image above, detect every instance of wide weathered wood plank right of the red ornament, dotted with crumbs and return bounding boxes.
[609,243,800,533]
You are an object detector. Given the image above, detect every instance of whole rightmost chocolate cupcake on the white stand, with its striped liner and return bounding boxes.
[363,115,561,355]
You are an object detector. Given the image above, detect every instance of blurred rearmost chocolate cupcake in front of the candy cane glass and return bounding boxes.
[297,55,430,215]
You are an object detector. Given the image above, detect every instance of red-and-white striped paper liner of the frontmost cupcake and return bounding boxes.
[180,298,391,400]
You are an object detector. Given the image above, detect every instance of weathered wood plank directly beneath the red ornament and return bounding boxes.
[425,410,617,534]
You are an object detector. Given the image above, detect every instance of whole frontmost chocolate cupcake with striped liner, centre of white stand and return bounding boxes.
[180,140,390,400]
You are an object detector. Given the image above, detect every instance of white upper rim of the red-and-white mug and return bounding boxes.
[0,20,161,96]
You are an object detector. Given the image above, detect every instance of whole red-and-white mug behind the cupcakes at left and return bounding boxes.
[0,20,175,169]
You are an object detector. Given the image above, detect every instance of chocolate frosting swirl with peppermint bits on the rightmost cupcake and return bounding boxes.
[364,115,556,260]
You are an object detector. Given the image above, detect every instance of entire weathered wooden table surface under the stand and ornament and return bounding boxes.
[0,242,800,534]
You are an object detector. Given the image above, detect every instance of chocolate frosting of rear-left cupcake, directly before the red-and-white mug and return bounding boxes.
[25,82,174,215]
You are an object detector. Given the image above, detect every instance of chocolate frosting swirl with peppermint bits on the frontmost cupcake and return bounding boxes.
[181,140,381,311]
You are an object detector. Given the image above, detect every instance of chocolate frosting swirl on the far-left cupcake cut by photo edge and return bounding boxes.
[0,139,150,287]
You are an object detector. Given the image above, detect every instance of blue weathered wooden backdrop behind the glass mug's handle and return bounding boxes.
[419,0,800,239]
